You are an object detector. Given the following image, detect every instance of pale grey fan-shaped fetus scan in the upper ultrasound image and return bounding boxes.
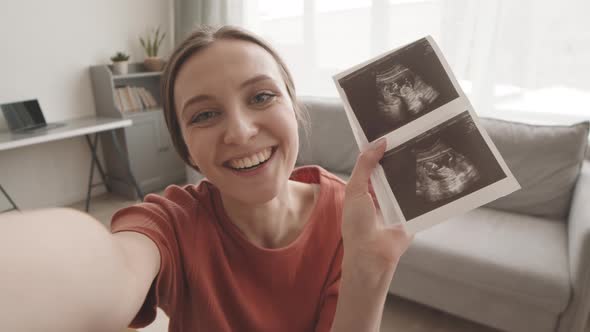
[376,64,439,123]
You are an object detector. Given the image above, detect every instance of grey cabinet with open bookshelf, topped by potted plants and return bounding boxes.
[90,63,186,199]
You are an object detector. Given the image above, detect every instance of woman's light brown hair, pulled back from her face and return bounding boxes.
[161,25,309,171]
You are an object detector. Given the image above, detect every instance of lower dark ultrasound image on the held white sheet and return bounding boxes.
[380,111,506,221]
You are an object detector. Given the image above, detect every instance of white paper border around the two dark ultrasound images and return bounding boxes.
[333,36,520,234]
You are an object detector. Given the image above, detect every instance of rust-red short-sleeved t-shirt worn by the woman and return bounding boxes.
[111,166,345,332]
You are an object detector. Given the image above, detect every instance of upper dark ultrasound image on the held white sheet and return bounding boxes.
[338,38,459,141]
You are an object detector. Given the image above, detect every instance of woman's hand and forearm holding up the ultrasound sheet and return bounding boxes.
[332,140,413,332]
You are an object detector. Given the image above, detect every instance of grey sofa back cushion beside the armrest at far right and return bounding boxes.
[481,118,589,220]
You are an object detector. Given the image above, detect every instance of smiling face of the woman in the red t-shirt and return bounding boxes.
[174,40,299,204]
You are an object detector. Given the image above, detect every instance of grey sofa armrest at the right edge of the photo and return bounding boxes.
[559,160,590,331]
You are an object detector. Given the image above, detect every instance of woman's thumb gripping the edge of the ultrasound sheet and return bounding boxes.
[346,138,387,196]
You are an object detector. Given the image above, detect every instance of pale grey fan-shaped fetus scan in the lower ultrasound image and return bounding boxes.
[414,139,480,202]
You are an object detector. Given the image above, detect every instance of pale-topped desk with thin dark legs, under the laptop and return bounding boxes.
[0,116,143,212]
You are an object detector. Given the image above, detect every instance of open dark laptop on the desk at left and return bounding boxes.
[0,99,64,133]
